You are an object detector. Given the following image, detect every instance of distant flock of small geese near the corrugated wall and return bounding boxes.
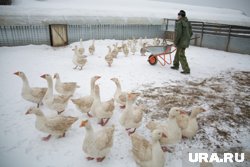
[72,37,166,70]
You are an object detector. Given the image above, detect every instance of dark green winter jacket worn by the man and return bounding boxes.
[174,17,193,48]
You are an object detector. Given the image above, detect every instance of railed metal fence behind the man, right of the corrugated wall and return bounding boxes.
[165,19,250,54]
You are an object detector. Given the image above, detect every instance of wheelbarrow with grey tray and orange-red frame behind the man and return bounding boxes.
[147,44,176,66]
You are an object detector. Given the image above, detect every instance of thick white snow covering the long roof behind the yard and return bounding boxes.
[0,0,250,26]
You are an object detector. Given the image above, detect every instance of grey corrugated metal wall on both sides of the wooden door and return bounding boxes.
[0,24,164,46]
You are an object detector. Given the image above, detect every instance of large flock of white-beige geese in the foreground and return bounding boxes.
[14,38,205,167]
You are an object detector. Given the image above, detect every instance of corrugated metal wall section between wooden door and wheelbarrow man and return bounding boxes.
[68,24,164,43]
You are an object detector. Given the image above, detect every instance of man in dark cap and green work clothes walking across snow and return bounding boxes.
[171,10,193,74]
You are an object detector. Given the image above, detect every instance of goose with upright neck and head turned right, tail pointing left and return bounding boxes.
[71,76,101,117]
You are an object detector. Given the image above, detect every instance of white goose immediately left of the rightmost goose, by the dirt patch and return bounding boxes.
[146,107,182,152]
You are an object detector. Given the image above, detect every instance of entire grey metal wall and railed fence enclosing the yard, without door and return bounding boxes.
[0,19,250,54]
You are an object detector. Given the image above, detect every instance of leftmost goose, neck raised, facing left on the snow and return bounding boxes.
[14,71,47,107]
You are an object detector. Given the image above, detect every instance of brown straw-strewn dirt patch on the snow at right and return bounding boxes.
[139,71,250,153]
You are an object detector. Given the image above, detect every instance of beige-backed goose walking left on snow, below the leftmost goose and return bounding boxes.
[25,107,78,141]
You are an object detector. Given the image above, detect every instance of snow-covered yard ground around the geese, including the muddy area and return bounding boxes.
[0,40,250,167]
